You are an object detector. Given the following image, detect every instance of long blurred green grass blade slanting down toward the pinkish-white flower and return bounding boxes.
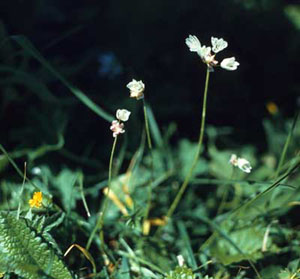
[10,35,114,122]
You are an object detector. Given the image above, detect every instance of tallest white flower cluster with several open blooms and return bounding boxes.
[185,35,240,71]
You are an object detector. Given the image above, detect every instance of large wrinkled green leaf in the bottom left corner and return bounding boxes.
[0,212,73,279]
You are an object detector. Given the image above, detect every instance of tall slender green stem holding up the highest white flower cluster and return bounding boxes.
[167,68,210,220]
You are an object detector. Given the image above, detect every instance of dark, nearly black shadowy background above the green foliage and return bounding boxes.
[0,0,300,173]
